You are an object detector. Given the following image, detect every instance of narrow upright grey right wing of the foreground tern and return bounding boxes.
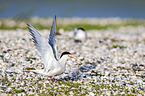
[48,16,57,60]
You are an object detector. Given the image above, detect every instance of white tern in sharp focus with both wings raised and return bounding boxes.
[24,16,73,81]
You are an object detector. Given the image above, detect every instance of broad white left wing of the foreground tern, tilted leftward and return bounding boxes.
[27,24,54,70]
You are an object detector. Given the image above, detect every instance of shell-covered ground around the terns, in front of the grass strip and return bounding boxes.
[0,18,145,96]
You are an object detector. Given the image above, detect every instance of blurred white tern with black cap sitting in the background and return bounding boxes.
[74,28,88,42]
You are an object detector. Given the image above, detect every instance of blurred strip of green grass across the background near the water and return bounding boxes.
[0,18,145,31]
